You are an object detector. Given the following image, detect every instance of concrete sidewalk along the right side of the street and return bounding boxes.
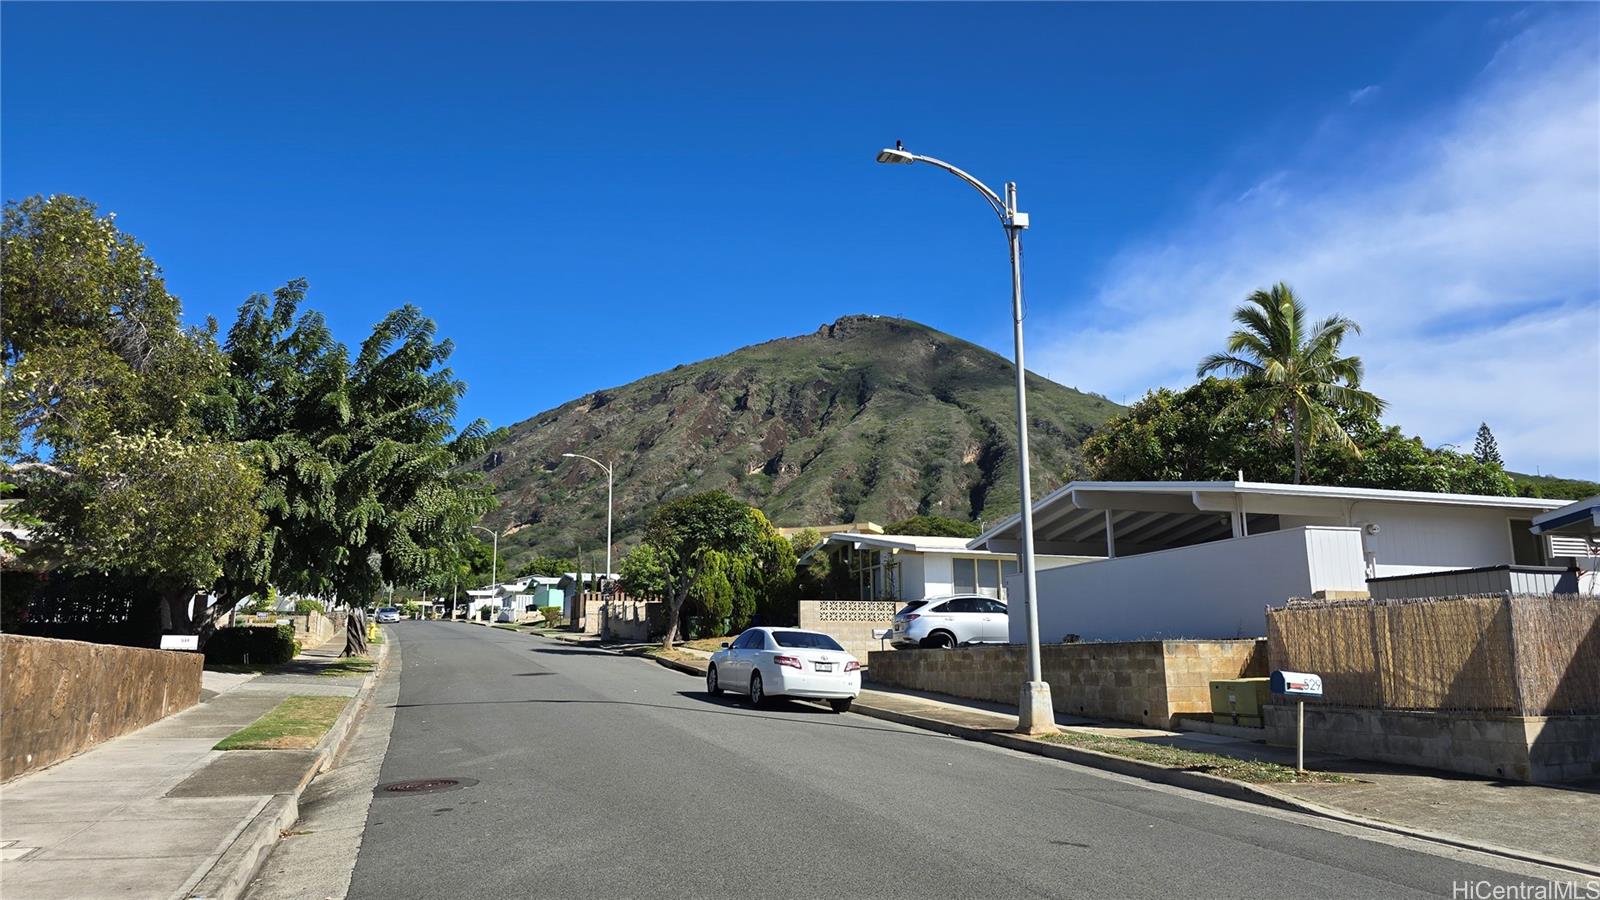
[643,647,1600,876]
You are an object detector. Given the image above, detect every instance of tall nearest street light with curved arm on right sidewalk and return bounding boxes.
[878,141,1056,735]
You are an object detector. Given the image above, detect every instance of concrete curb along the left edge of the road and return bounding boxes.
[184,636,389,900]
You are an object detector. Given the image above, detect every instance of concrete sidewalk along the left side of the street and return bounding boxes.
[0,634,384,900]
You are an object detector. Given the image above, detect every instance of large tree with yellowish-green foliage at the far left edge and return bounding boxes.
[0,197,259,631]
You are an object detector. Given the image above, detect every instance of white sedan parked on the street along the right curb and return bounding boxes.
[706,628,861,713]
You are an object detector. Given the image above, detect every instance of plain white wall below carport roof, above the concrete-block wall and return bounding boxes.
[1008,527,1366,644]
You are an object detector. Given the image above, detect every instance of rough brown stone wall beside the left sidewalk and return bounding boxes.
[0,634,205,780]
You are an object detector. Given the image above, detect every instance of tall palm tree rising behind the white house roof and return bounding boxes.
[1195,282,1386,484]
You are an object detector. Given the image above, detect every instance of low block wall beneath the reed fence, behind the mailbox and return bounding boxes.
[1264,703,1600,783]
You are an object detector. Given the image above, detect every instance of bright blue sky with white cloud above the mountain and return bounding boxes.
[0,2,1600,477]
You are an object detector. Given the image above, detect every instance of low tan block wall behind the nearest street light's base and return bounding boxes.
[869,641,1267,729]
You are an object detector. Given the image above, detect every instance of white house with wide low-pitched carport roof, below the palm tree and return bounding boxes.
[971,482,1562,642]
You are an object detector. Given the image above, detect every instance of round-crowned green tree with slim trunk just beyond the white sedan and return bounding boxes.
[645,490,760,649]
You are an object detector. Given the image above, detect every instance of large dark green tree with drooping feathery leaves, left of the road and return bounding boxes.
[211,282,491,605]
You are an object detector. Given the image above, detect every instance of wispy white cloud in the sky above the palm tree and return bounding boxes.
[1032,11,1600,479]
